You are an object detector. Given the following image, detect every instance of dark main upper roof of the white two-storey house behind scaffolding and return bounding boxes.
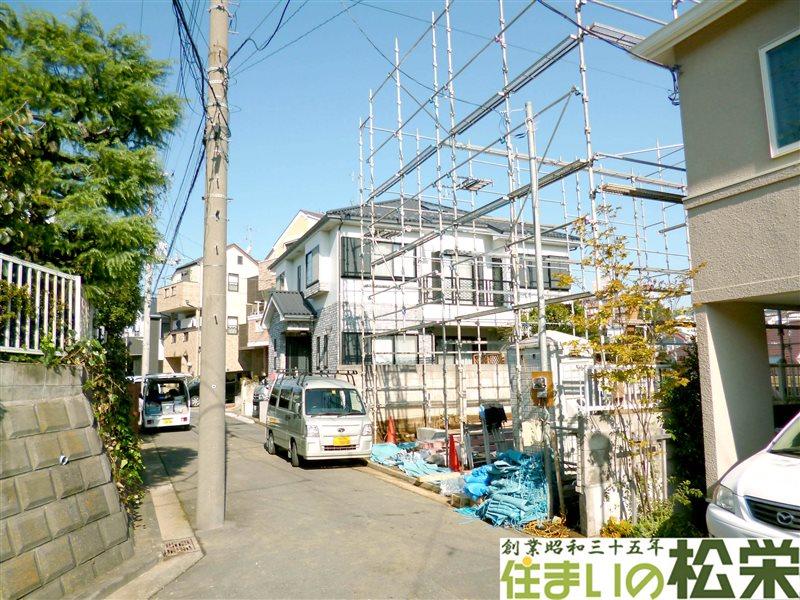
[269,198,567,269]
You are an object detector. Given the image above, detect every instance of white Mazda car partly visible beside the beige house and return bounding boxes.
[706,414,800,538]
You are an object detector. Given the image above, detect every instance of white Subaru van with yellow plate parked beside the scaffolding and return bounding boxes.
[262,377,372,467]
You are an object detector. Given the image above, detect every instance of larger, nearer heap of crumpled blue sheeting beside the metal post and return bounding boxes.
[458,450,549,527]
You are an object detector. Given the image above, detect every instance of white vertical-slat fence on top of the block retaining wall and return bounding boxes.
[0,253,82,354]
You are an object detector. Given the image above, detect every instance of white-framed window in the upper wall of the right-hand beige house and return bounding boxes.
[759,31,800,156]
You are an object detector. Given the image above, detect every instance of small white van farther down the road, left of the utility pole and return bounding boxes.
[139,374,192,431]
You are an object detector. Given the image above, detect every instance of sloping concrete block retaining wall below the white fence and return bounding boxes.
[0,363,133,599]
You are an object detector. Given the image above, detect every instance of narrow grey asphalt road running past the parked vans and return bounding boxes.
[152,418,508,598]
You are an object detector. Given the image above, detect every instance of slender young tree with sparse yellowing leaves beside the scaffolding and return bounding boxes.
[569,206,694,518]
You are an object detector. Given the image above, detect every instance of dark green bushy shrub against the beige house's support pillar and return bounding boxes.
[660,342,706,489]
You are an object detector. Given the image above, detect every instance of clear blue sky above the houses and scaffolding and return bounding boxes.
[15,0,681,286]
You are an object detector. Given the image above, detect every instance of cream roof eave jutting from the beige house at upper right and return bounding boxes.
[633,0,746,66]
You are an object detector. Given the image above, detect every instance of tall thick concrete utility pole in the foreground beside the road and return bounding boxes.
[197,0,229,529]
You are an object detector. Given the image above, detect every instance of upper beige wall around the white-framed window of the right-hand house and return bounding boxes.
[675,0,800,196]
